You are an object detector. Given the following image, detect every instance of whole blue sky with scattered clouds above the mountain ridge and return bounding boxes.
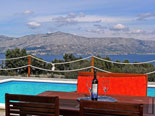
[0,0,155,40]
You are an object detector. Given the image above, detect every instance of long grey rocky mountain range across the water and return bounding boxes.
[0,32,155,55]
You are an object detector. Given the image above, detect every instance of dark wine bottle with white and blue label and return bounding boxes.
[91,70,98,100]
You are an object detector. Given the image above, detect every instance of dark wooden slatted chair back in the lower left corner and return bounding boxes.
[5,94,59,116]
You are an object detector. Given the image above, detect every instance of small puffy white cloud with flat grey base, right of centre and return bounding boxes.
[110,24,129,31]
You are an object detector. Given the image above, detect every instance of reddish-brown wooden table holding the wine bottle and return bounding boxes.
[39,91,155,116]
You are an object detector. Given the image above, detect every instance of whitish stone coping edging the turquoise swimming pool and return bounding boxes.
[0,78,155,109]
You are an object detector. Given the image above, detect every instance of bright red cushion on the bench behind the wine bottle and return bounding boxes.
[77,73,147,96]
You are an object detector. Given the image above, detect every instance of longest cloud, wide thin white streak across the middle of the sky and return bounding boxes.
[30,13,135,24]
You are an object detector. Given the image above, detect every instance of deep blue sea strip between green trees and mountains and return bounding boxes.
[0,54,155,64]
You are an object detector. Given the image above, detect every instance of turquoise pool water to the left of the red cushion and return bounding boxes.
[0,81,77,103]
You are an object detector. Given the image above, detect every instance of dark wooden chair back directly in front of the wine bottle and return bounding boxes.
[80,100,143,116]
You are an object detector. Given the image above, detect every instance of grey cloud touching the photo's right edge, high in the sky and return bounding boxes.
[137,13,155,21]
